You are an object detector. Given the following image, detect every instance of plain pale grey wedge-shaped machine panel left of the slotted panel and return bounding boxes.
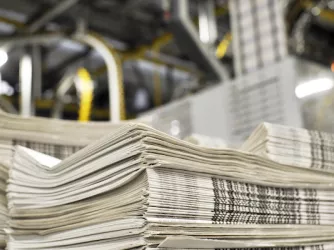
[138,83,231,140]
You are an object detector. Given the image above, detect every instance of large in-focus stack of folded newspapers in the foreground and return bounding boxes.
[7,124,334,250]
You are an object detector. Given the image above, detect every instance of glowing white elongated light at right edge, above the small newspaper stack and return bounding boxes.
[295,78,334,98]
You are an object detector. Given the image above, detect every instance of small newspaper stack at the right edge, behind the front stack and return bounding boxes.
[242,123,334,172]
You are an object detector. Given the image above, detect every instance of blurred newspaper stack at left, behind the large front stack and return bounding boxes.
[0,110,126,249]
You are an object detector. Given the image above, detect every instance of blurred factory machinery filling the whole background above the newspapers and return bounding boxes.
[0,0,334,143]
